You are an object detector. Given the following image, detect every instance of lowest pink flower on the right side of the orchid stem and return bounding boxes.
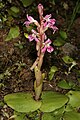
[41,39,54,53]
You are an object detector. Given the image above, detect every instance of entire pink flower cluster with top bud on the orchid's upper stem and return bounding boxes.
[24,4,58,53]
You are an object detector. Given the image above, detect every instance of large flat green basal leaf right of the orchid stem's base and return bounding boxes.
[40,91,68,112]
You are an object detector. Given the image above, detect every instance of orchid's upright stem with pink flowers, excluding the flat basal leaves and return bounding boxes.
[24,4,58,100]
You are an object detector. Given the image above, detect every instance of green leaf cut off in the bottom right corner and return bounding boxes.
[63,111,80,120]
